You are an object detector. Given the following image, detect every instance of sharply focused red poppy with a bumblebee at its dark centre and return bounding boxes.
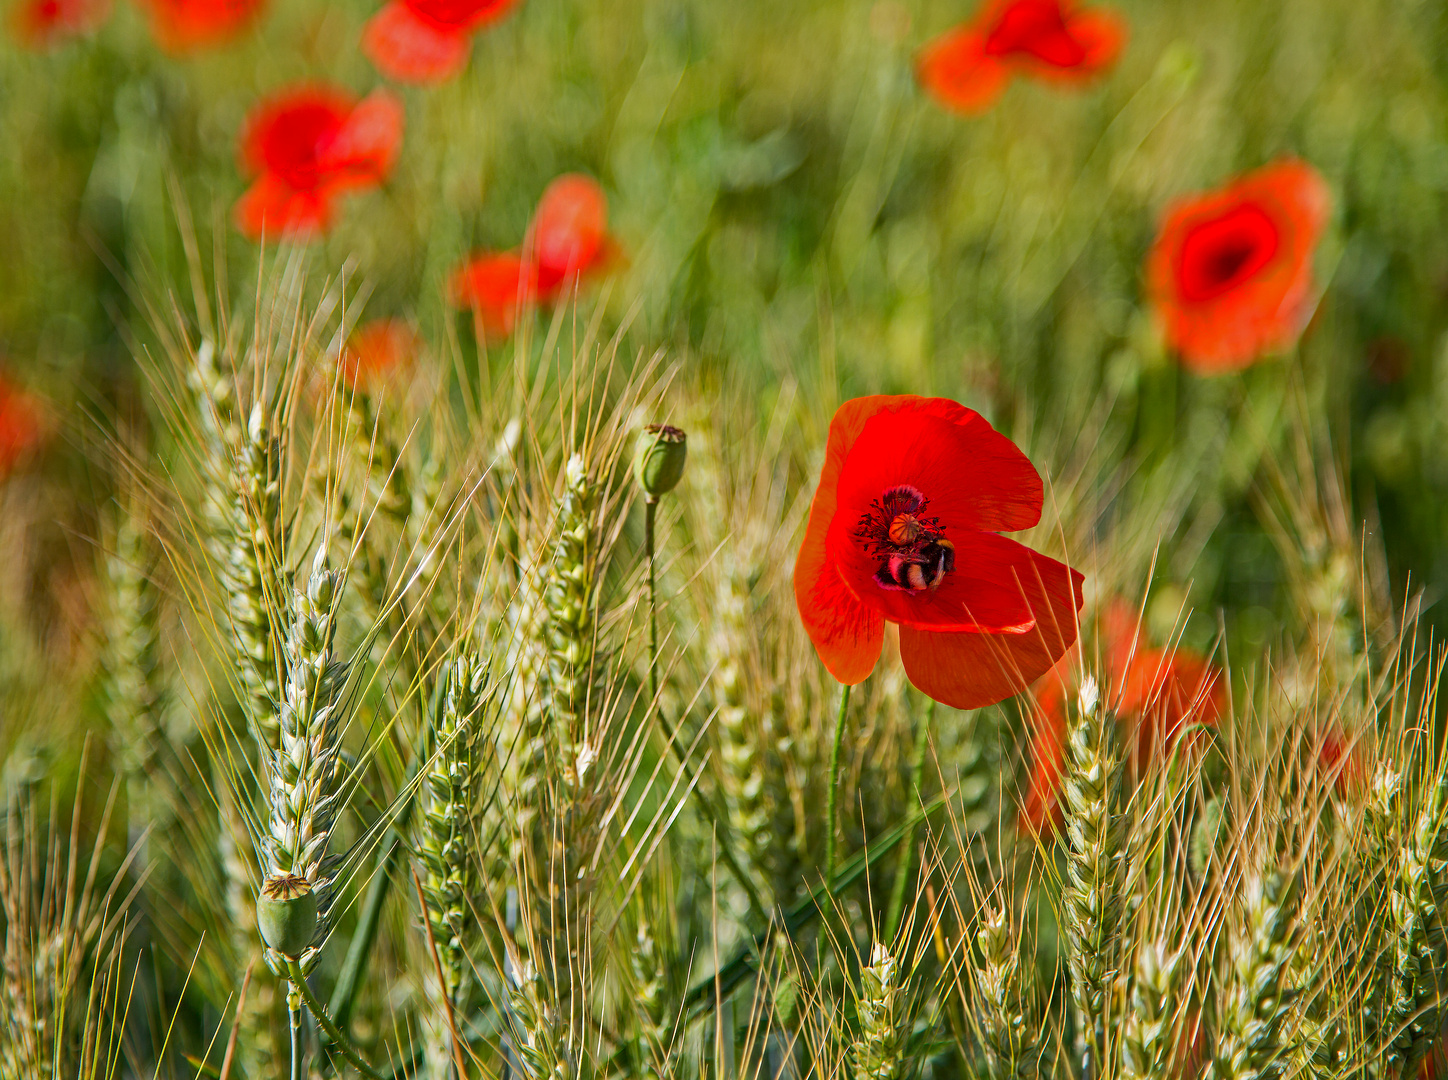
[795,395,1082,708]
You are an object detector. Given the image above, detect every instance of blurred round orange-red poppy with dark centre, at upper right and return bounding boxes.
[1147,161,1332,375]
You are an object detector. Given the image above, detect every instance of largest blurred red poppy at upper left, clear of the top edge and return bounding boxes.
[235,87,403,237]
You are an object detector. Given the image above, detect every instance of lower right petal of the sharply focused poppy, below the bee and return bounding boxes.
[901,552,1085,709]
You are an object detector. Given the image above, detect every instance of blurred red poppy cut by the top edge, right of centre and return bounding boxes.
[915,0,1127,113]
